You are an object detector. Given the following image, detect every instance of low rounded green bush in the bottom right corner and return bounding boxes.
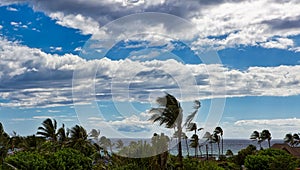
[245,149,296,170]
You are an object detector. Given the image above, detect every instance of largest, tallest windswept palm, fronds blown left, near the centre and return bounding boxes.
[149,93,183,167]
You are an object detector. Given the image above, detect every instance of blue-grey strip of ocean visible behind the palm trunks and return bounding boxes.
[111,138,283,156]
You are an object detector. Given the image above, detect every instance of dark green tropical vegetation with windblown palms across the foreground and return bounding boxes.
[0,94,300,170]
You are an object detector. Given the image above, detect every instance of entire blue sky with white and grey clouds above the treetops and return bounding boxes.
[0,0,300,139]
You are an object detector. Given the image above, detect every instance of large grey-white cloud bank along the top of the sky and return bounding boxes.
[2,0,300,50]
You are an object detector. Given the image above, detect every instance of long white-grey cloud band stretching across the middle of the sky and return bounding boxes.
[0,40,300,107]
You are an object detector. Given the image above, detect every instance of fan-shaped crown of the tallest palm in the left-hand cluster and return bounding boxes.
[37,118,57,141]
